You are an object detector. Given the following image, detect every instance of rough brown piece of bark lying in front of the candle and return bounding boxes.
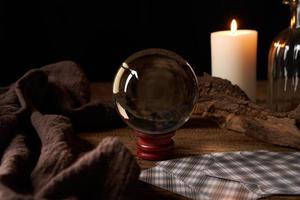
[193,74,300,149]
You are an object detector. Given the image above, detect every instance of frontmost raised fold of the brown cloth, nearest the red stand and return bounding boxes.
[36,138,139,199]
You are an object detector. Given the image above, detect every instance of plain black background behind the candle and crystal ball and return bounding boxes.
[0,0,289,85]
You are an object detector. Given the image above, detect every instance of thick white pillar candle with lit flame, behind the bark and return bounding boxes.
[211,20,258,101]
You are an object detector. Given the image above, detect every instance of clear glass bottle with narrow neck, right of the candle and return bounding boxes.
[268,0,300,112]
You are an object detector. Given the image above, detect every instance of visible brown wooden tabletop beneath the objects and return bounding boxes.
[80,81,300,200]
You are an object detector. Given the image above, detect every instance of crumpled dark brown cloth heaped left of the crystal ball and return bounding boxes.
[0,61,140,200]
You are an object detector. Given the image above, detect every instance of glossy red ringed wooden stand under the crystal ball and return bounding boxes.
[135,131,175,161]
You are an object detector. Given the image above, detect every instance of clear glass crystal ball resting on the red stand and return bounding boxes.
[113,49,198,134]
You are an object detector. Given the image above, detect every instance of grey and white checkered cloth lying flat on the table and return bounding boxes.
[140,151,300,200]
